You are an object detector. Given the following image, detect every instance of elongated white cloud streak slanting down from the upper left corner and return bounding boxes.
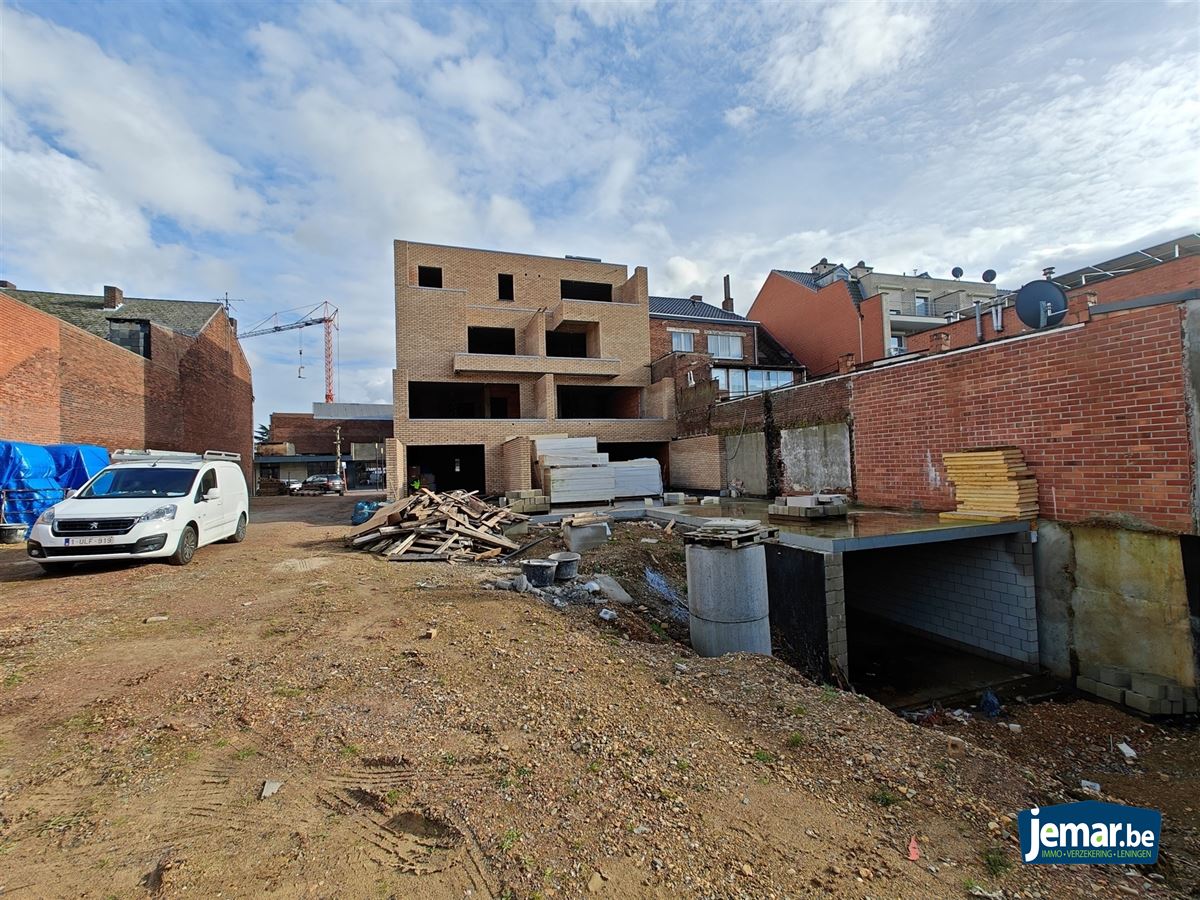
[4,7,260,230]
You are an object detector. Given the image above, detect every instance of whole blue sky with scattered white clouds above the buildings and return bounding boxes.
[0,0,1200,421]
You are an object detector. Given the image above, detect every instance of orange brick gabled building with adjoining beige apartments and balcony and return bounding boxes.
[750,259,996,376]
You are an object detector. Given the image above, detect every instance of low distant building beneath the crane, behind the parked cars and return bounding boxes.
[254,403,394,491]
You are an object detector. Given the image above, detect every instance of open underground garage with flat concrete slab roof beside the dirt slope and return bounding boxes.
[767,511,1038,708]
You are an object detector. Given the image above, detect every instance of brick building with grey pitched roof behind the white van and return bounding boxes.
[0,282,253,478]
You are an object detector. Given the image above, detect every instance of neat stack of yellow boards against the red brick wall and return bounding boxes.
[941,448,1038,522]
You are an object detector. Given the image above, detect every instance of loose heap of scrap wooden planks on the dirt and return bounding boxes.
[346,488,528,563]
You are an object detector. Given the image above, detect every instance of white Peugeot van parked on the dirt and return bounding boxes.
[26,450,250,570]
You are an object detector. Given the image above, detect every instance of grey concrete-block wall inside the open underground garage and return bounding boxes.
[842,535,1038,666]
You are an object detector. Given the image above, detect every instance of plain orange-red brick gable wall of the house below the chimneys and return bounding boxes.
[748,272,868,377]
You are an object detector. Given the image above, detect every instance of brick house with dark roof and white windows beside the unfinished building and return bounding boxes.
[650,295,804,397]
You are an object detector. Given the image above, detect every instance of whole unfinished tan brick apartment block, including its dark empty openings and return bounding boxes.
[388,241,674,494]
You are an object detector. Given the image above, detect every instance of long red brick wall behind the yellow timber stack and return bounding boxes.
[851,305,1193,532]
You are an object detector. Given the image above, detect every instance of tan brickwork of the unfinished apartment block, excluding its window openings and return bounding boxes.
[389,241,676,493]
